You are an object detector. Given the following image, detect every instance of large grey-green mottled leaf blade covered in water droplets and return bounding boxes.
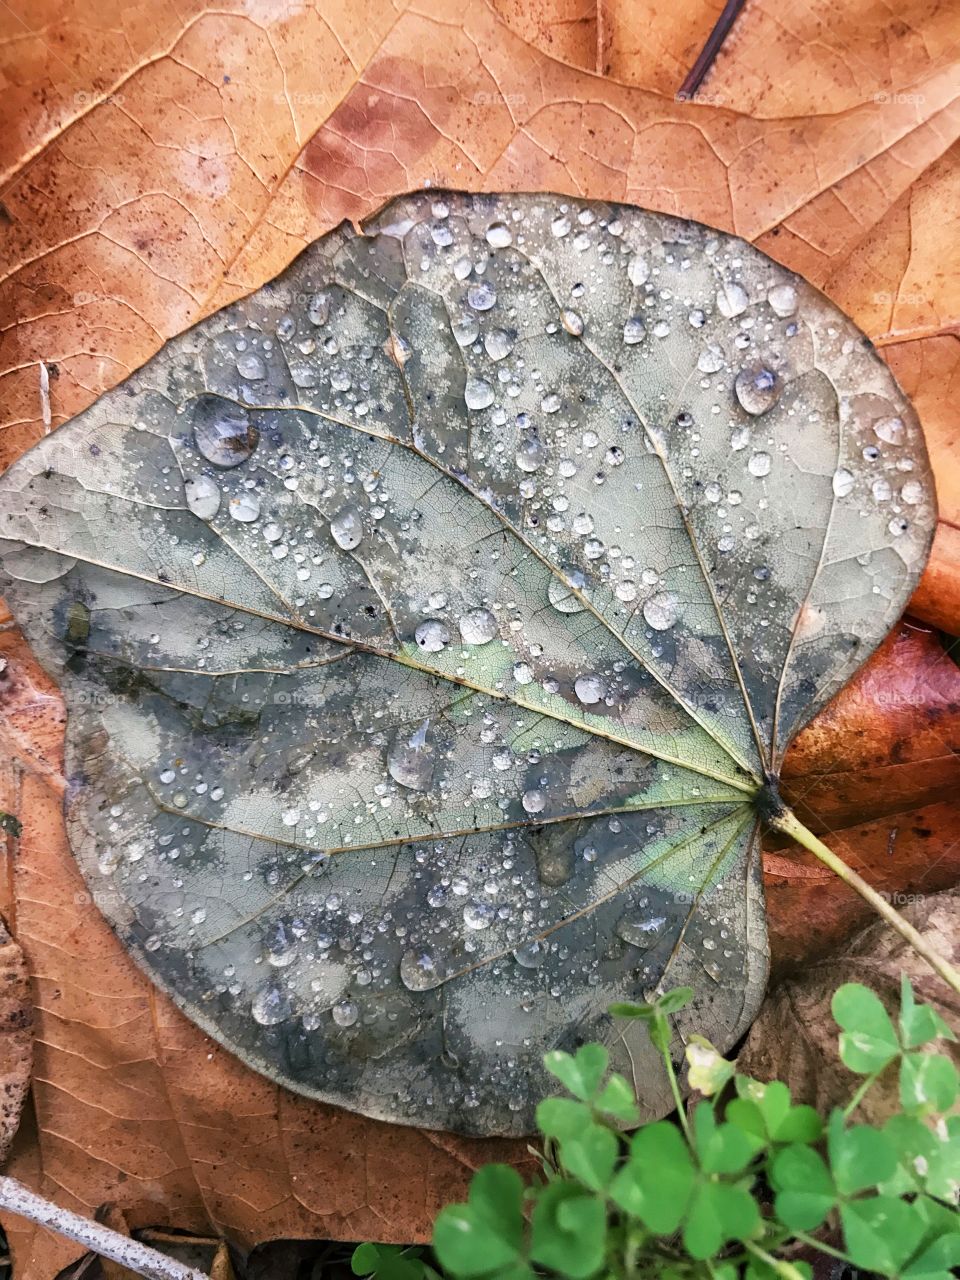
[0,195,936,1133]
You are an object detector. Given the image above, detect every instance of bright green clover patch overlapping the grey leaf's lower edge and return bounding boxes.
[353,978,960,1280]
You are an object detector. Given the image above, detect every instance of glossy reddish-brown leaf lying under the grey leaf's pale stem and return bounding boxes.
[764,621,960,973]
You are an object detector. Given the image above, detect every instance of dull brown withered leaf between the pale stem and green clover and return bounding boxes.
[737,890,960,1124]
